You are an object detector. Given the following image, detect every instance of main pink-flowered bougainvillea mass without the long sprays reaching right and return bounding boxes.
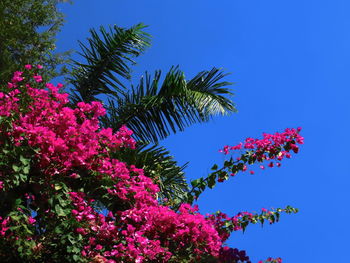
[0,65,222,263]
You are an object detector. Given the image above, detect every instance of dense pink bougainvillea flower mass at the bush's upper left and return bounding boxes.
[7,81,135,174]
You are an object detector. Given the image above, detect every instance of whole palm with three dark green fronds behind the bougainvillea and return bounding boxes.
[69,24,235,204]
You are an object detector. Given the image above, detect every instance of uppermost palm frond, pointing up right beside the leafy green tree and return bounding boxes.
[68,24,150,102]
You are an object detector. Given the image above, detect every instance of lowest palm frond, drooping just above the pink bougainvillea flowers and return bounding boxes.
[113,144,189,204]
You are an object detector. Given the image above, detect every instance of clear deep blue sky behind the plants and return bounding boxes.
[57,0,350,263]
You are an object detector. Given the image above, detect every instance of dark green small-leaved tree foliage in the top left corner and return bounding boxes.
[0,0,69,85]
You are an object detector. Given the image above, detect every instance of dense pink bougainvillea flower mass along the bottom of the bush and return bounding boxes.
[70,192,221,263]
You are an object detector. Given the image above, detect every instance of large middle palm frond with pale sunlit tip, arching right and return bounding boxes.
[104,67,235,143]
